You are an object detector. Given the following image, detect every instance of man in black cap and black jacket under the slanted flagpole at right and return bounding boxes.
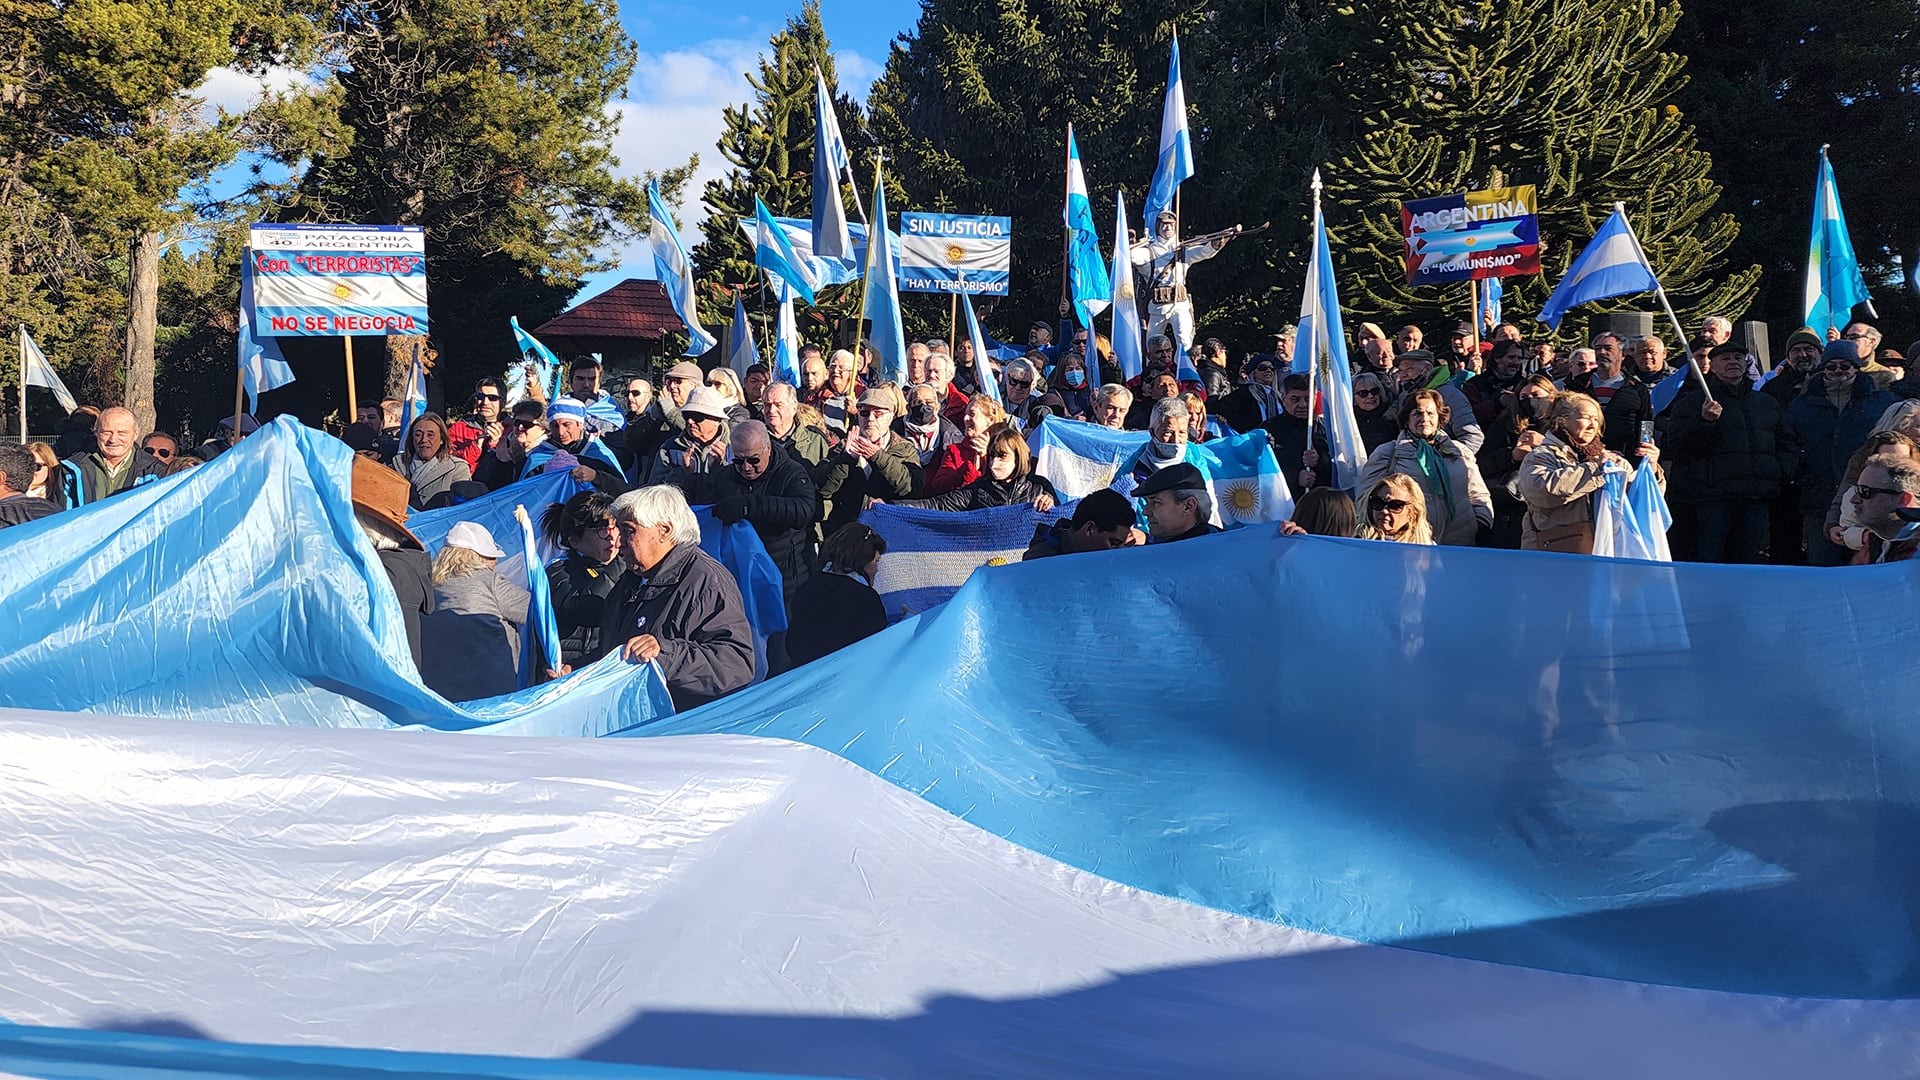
[1667,342,1799,563]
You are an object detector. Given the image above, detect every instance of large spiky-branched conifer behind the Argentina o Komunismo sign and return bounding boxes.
[1327,0,1759,332]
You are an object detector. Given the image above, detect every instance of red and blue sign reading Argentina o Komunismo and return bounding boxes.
[1400,184,1540,284]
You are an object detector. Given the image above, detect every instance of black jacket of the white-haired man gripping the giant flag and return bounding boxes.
[593,544,753,713]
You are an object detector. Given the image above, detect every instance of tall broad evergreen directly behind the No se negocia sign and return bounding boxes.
[269,0,691,396]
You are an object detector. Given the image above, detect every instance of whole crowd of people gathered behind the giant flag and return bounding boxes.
[0,307,1920,707]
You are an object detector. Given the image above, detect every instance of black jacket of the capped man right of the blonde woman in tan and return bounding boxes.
[1667,377,1799,503]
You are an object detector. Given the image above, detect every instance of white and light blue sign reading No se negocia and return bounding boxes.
[248,225,426,336]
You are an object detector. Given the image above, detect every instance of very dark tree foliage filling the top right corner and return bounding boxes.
[1672,0,1920,334]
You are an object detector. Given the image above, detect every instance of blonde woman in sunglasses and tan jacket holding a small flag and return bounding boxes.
[1519,390,1667,555]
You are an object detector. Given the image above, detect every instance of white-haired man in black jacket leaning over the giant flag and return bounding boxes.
[579,484,753,711]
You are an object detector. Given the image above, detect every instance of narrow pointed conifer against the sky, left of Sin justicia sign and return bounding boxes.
[693,0,868,354]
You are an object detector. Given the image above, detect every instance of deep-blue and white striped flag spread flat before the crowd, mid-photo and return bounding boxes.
[860,499,1062,623]
